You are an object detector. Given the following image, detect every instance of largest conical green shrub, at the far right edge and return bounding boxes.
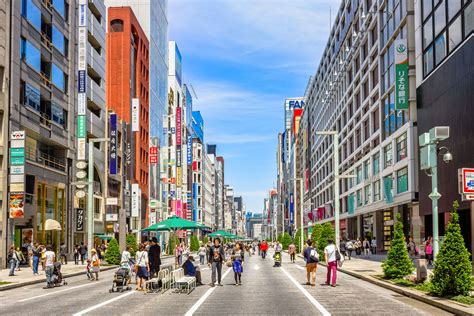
[431,201,472,296]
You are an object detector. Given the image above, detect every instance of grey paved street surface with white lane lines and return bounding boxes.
[0,254,448,316]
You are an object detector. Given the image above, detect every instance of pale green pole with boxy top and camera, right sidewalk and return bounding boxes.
[419,126,453,259]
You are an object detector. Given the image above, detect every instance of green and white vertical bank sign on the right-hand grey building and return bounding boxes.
[394,39,409,110]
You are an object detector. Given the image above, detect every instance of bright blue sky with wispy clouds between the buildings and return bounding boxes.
[168,0,340,212]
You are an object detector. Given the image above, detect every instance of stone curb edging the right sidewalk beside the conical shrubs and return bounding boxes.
[319,263,474,315]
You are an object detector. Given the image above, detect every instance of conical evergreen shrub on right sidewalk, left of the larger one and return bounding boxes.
[382,213,414,279]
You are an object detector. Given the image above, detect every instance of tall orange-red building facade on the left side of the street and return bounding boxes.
[106,7,149,227]
